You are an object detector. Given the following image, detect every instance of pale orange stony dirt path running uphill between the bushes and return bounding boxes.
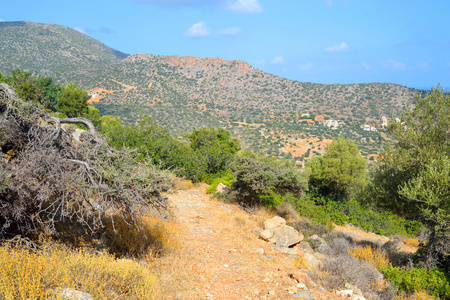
[163,185,332,299]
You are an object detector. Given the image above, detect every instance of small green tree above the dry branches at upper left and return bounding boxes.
[56,83,89,118]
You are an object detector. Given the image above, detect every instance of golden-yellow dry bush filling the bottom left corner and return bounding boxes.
[0,246,160,300]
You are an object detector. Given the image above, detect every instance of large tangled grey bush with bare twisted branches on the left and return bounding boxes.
[0,85,172,243]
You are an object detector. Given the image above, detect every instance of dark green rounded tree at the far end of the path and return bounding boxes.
[186,127,241,180]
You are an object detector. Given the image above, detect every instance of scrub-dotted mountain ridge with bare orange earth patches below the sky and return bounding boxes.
[0,22,419,157]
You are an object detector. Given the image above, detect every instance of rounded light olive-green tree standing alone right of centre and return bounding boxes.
[306,136,367,199]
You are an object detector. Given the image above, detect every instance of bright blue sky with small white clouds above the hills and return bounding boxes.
[0,0,450,89]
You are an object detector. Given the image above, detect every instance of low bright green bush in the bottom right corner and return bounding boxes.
[379,264,450,299]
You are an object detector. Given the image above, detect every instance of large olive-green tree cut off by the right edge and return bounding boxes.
[370,85,450,273]
